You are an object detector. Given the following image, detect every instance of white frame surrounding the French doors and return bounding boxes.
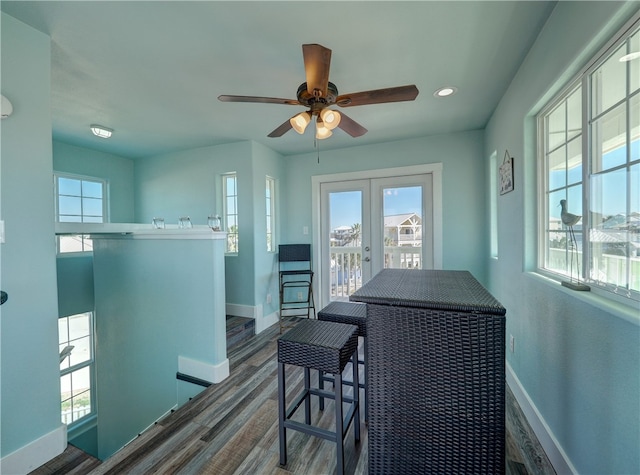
[311,163,442,303]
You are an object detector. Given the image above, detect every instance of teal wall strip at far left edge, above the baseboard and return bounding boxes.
[0,13,61,462]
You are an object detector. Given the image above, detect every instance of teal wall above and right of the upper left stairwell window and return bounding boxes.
[53,139,135,223]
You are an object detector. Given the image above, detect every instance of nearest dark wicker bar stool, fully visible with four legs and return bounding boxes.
[278,320,360,474]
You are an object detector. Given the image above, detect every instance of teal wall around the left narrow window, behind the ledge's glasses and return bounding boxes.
[135,142,279,306]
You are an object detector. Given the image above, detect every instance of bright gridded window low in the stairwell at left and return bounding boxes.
[58,312,95,425]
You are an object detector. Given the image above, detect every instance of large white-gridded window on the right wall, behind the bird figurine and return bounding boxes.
[538,20,640,300]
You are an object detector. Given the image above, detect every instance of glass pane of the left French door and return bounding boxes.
[329,191,362,300]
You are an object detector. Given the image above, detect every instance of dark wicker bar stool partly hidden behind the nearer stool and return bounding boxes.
[318,301,368,420]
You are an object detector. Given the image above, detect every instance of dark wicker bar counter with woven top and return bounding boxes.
[350,269,506,474]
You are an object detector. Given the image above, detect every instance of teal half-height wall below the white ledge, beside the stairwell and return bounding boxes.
[94,238,227,459]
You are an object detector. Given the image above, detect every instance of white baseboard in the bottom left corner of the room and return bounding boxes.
[0,424,67,475]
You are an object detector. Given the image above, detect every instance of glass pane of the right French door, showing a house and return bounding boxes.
[382,186,423,269]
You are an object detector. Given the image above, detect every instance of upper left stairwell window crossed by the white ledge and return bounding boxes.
[54,174,107,253]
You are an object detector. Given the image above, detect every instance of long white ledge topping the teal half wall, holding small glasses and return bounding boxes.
[56,223,227,239]
